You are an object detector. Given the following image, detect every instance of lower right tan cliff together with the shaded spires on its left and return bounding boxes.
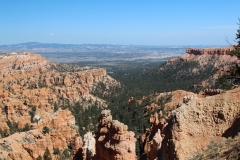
[142,88,240,160]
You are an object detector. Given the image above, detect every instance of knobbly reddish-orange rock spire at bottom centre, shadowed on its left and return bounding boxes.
[95,110,136,160]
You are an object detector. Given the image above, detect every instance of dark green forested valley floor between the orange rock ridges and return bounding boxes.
[64,60,218,155]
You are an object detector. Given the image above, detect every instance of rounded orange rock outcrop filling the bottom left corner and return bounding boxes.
[0,110,81,160]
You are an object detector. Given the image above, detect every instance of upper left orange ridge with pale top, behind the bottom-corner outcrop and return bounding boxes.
[0,52,119,128]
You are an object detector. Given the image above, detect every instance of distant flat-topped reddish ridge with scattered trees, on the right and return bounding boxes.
[165,46,240,89]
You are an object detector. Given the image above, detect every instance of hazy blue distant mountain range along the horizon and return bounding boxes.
[0,42,228,53]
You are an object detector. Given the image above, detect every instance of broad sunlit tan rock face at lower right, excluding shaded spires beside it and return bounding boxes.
[172,88,240,159]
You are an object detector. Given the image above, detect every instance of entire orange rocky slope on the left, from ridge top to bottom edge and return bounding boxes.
[0,52,119,160]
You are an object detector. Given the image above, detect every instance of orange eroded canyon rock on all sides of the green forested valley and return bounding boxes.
[0,47,240,160]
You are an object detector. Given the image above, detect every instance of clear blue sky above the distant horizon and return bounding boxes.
[0,0,240,45]
